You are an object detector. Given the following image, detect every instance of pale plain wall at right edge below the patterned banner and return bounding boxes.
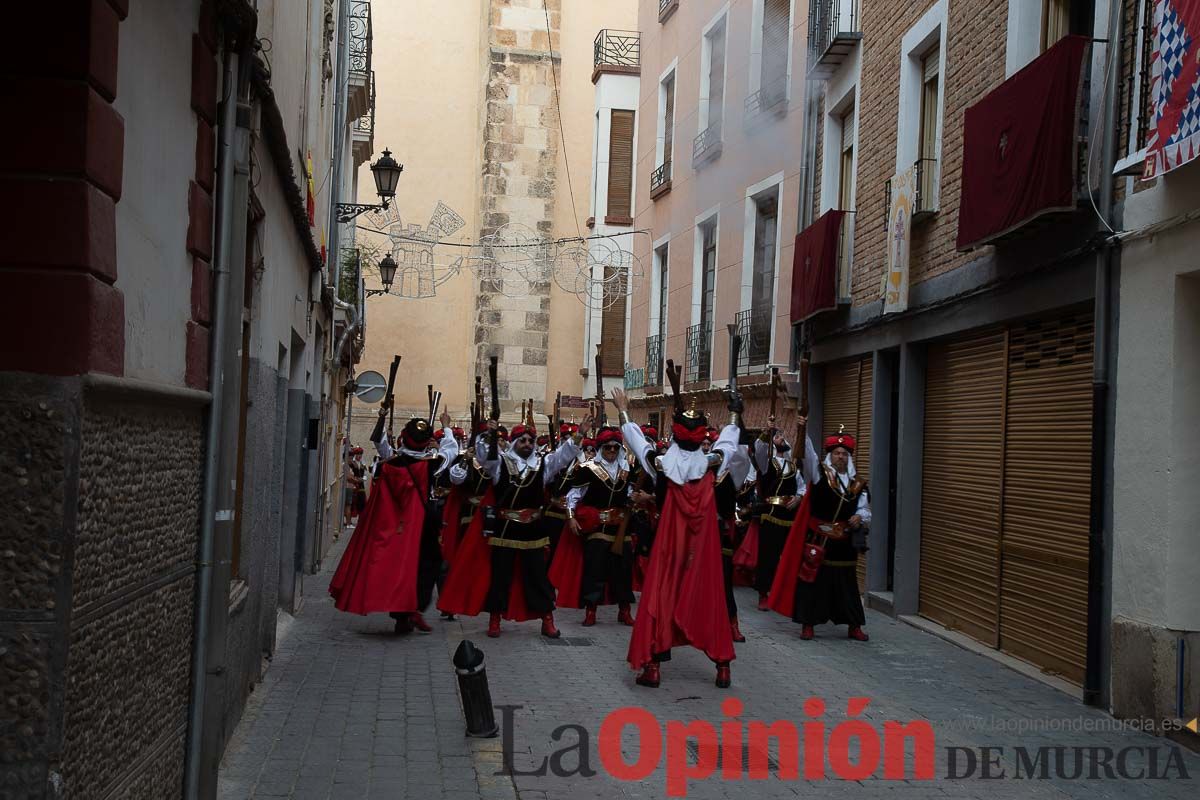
[1112,163,1200,631]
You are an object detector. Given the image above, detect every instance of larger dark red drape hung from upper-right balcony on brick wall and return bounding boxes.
[958,36,1091,249]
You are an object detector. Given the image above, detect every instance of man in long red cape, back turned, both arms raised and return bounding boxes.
[613,388,750,688]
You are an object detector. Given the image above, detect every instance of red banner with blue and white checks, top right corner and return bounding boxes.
[1142,0,1200,179]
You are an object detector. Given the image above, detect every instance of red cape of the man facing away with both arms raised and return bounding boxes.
[626,473,734,669]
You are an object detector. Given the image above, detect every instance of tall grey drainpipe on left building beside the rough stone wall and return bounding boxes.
[184,48,250,800]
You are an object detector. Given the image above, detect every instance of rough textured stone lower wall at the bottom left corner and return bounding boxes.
[0,374,205,799]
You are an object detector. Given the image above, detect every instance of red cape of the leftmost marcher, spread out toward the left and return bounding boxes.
[329,462,430,614]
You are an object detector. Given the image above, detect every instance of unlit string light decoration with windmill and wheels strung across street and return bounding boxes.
[367,201,643,309]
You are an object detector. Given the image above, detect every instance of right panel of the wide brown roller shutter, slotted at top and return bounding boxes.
[1000,313,1093,684]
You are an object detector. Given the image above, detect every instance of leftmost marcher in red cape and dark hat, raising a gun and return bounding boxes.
[329,407,458,633]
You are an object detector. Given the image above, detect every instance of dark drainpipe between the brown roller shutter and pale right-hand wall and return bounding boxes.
[1084,0,1124,705]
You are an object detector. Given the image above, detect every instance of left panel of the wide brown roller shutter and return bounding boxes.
[918,331,1007,646]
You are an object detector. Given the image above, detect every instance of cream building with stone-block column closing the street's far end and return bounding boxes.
[353,0,636,441]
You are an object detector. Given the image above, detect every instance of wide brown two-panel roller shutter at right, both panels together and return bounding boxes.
[919,312,1093,684]
